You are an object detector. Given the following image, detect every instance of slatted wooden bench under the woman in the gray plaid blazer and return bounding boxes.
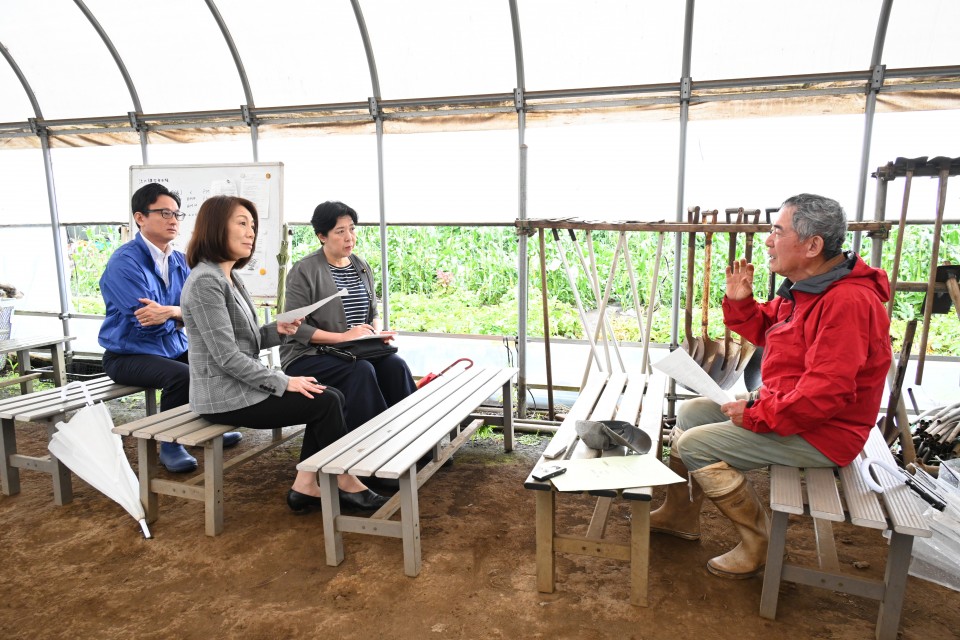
[113,405,303,536]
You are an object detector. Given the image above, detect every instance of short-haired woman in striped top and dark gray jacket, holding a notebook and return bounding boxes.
[280,202,416,436]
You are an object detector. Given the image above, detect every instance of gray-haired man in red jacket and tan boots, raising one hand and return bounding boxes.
[650,194,892,578]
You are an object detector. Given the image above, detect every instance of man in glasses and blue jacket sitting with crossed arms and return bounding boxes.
[98,182,243,473]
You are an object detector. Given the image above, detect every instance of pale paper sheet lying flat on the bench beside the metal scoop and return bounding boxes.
[550,454,683,491]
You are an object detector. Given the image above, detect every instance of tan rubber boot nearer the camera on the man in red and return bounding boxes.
[690,462,770,580]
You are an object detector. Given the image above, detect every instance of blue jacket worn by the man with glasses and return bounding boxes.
[98,233,190,358]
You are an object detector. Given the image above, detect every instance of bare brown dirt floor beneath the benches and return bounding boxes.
[0,390,960,640]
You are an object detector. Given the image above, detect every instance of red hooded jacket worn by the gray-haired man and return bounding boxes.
[723,253,892,466]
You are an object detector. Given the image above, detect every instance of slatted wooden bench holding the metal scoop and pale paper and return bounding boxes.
[523,372,667,607]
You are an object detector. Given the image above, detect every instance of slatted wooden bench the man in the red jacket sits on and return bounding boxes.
[760,428,932,640]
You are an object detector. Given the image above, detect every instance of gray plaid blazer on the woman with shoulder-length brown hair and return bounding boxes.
[180,262,289,414]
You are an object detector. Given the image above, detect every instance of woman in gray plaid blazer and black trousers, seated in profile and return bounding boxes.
[180,196,386,511]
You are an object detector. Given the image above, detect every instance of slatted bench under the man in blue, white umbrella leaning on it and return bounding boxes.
[0,376,157,505]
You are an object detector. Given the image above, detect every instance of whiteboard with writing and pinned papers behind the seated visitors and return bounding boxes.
[128,162,286,300]
